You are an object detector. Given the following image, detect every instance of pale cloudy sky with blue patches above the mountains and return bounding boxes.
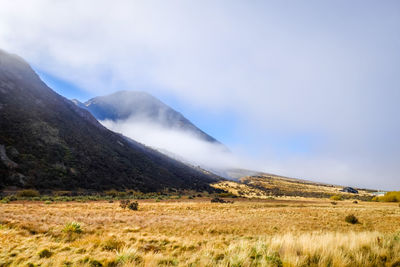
[0,0,400,190]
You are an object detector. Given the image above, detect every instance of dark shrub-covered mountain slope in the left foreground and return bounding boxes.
[0,50,216,192]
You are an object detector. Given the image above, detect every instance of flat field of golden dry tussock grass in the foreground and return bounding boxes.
[0,197,400,266]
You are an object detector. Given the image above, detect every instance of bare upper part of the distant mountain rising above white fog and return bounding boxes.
[80,91,220,144]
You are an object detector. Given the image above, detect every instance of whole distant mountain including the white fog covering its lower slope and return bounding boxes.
[78,91,239,173]
